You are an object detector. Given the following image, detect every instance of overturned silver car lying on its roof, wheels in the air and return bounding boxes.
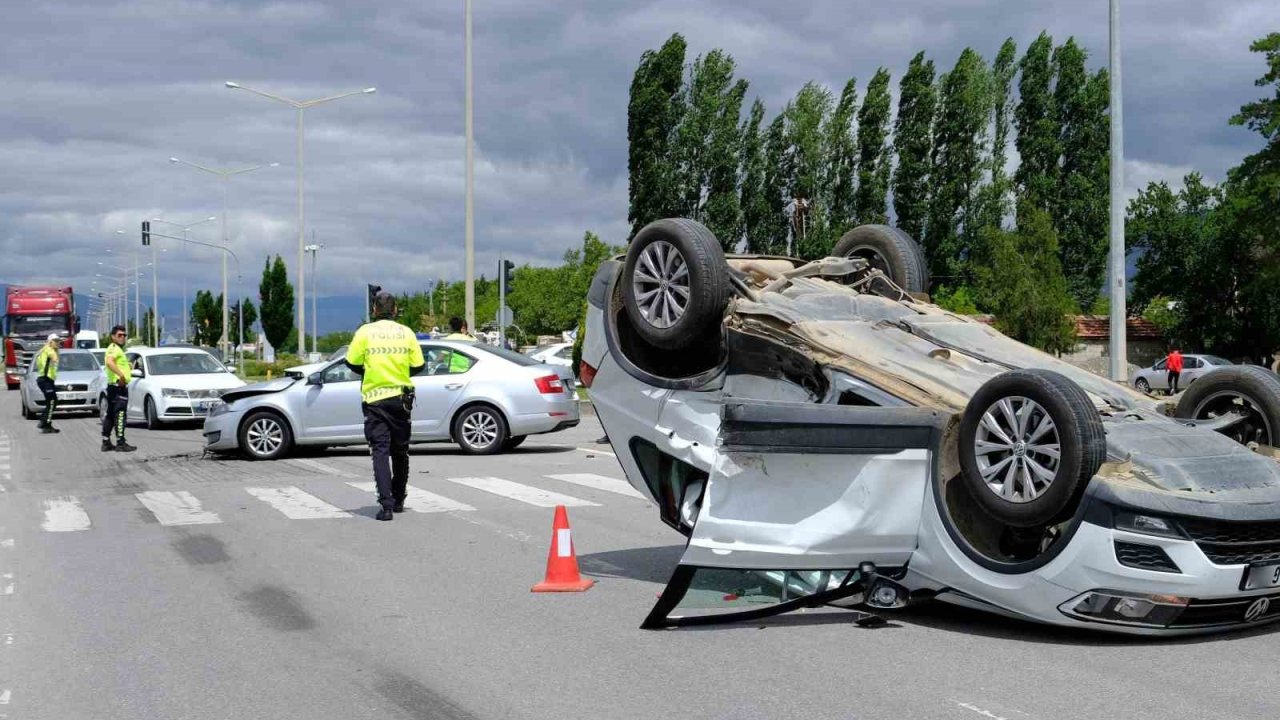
[582,219,1280,634]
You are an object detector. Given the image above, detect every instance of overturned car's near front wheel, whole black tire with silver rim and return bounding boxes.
[959,369,1107,528]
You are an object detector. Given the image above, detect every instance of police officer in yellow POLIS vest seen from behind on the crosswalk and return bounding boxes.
[346,292,426,520]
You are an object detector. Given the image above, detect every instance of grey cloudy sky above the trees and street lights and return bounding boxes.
[0,0,1280,316]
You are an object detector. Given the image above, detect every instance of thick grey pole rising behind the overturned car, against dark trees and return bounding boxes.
[1110,0,1129,383]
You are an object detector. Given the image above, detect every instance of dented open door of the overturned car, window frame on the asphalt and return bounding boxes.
[632,386,946,628]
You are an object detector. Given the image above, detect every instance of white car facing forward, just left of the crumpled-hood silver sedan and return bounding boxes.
[113,347,244,429]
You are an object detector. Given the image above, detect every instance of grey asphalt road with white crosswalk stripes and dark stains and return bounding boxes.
[0,393,1280,720]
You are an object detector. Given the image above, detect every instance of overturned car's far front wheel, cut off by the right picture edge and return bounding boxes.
[1174,365,1280,446]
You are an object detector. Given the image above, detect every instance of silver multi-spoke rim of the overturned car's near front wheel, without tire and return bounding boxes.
[974,396,1061,503]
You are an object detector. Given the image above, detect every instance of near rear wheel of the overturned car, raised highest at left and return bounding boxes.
[621,218,728,350]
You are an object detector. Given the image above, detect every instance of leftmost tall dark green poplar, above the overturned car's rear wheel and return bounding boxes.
[624,33,685,237]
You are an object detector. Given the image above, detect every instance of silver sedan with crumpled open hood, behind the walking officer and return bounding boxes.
[204,341,579,460]
